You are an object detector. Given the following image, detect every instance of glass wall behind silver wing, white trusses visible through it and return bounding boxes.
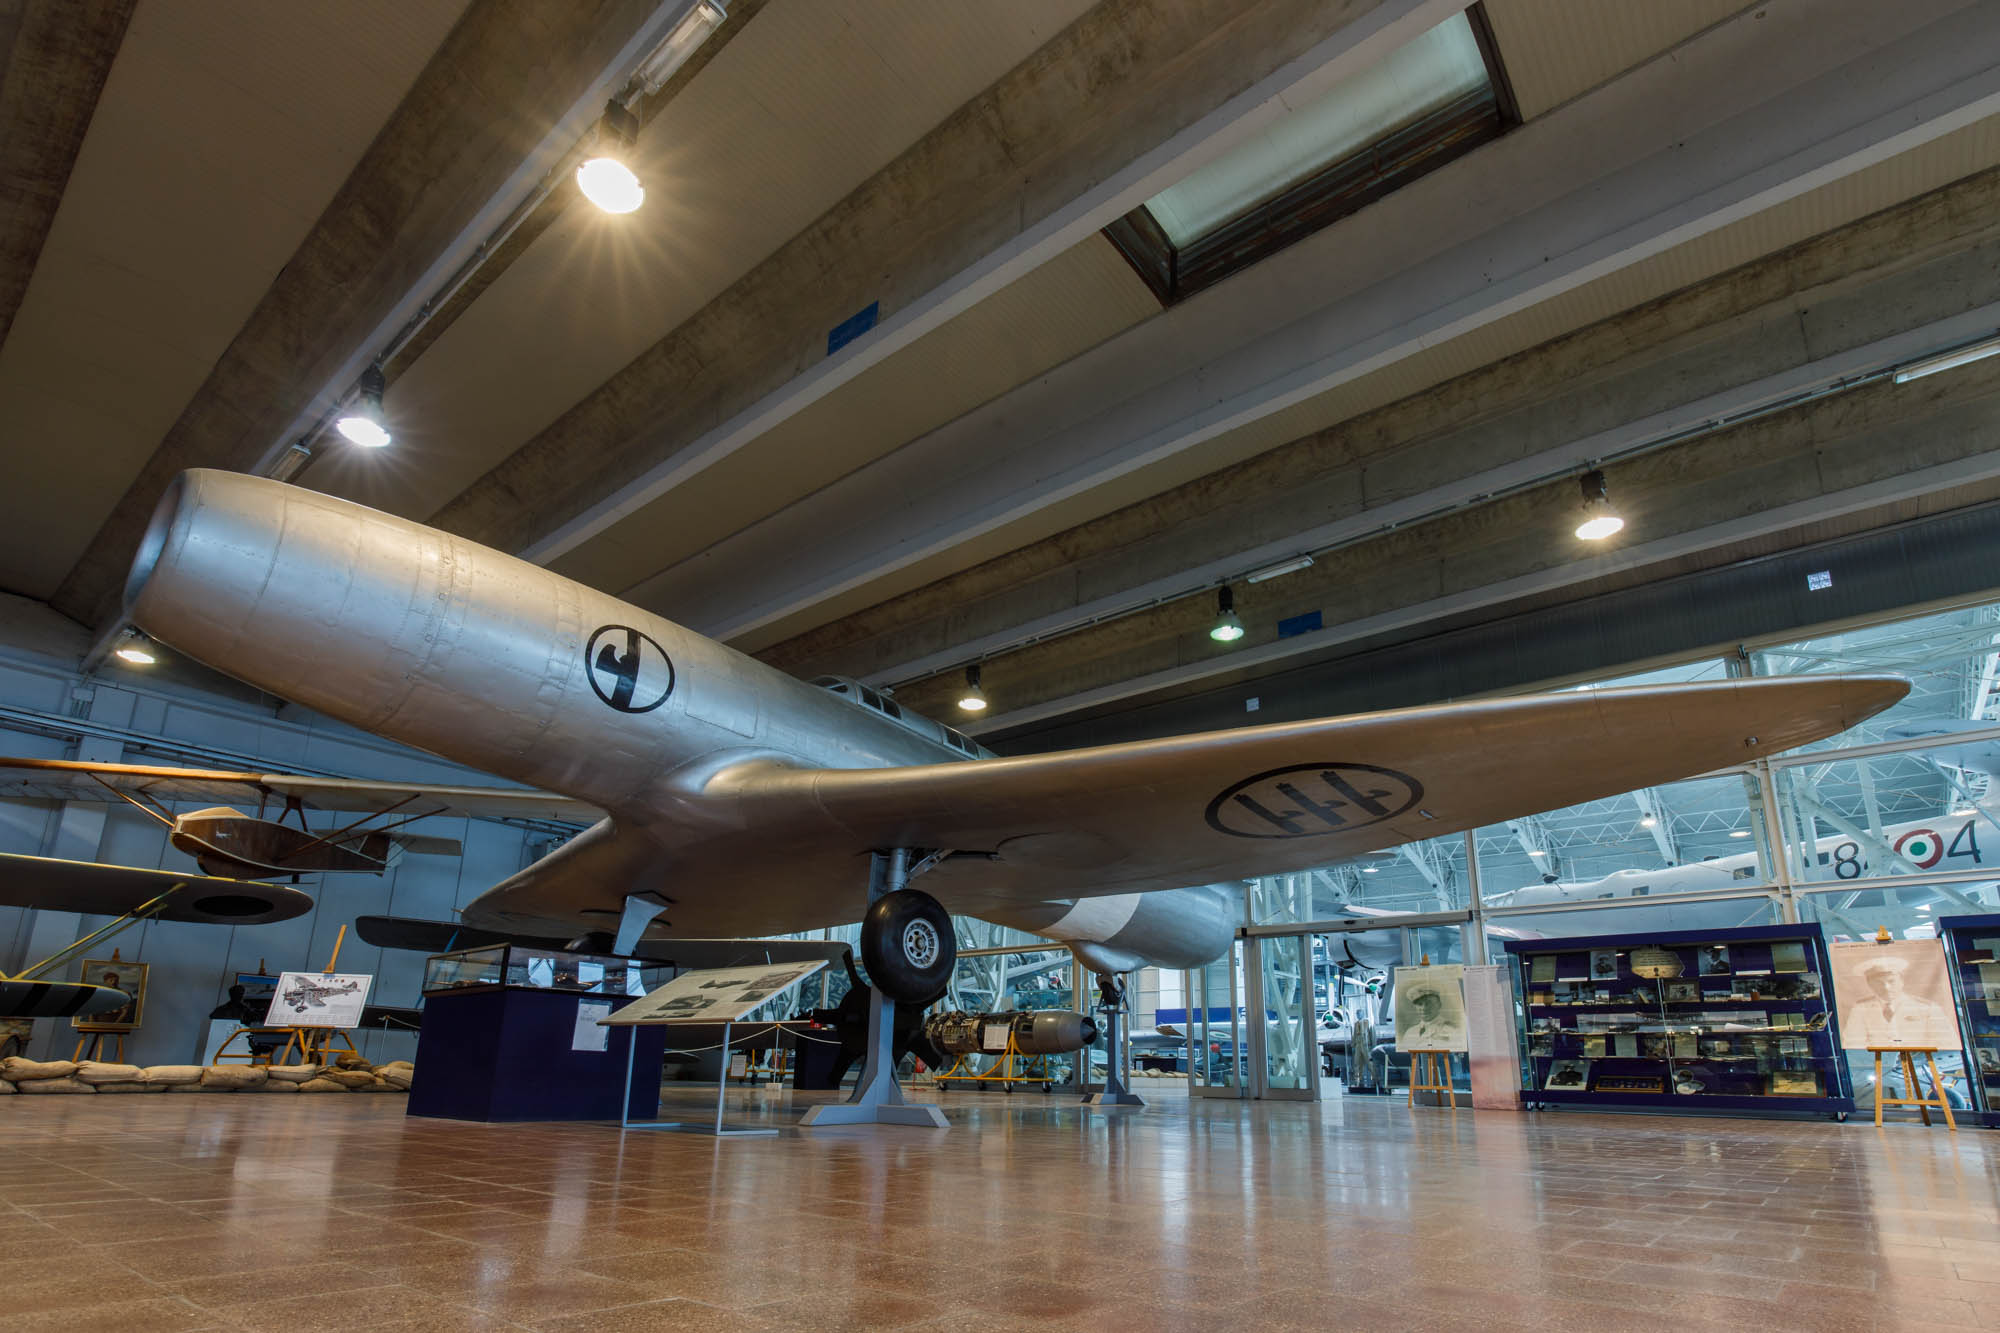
[1216,604,2000,1099]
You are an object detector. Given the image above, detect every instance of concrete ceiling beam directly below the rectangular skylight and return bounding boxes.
[660,0,2000,638]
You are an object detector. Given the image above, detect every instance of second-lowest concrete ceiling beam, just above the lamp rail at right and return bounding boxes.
[764,172,2000,685]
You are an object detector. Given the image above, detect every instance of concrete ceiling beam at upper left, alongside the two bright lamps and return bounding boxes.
[52,0,696,624]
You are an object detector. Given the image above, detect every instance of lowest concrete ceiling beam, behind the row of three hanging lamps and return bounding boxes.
[920,348,2000,735]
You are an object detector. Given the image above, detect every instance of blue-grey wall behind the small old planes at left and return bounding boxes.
[0,598,552,1065]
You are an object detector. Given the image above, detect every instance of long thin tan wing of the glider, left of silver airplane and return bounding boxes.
[0,757,602,820]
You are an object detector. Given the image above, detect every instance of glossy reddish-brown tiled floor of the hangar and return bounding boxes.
[0,1089,2000,1333]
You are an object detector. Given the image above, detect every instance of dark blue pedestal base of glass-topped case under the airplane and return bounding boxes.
[408,987,666,1121]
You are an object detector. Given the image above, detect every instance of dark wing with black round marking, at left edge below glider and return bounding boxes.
[0,855,312,925]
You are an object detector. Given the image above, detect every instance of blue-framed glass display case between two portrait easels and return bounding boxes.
[1506,925,1854,1119]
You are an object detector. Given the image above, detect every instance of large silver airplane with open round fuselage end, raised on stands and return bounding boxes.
[97,470,1908,1003]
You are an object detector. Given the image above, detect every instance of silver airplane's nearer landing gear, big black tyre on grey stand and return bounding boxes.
[800,847,958,1129]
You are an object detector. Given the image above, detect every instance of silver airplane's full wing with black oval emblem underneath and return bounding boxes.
[466,677,1910,935]
